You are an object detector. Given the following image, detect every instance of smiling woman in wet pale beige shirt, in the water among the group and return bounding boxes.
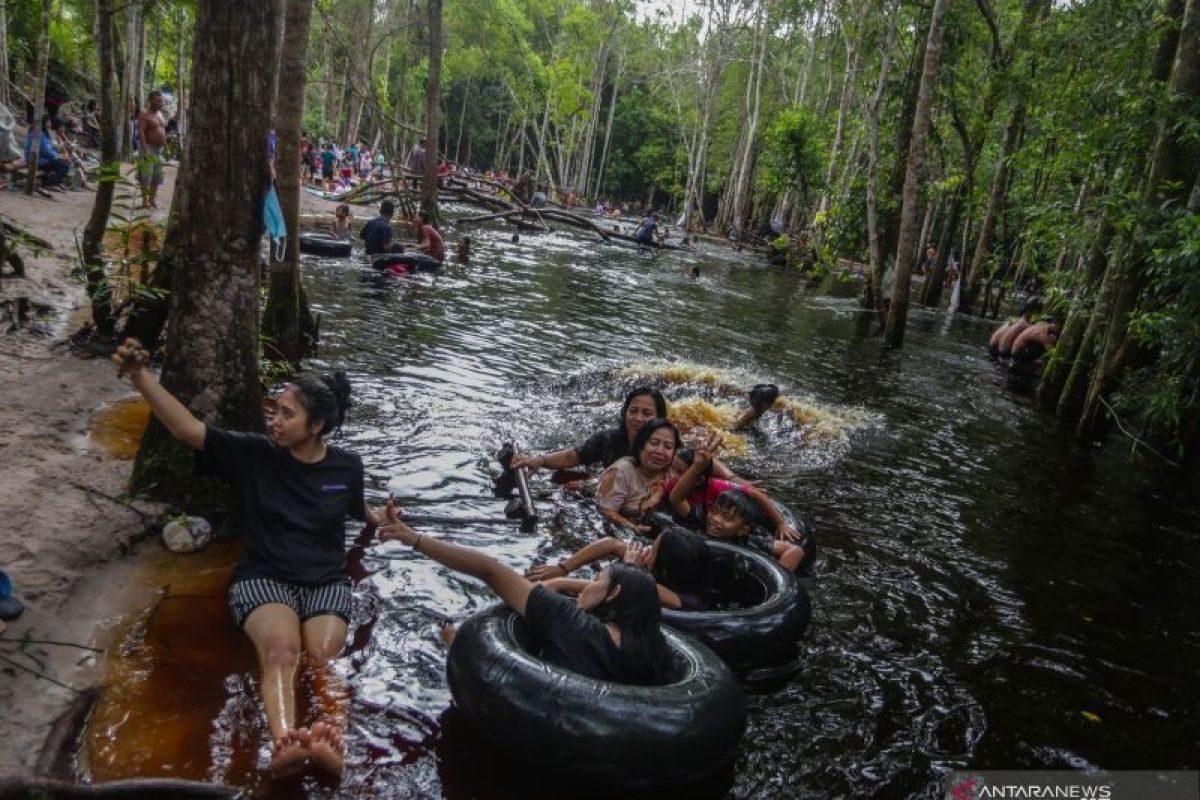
[596,417,680,535]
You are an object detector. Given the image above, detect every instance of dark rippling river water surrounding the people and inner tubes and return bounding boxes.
[88,209,1200,798]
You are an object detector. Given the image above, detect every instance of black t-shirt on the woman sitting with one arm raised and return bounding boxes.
[197,426,366,585]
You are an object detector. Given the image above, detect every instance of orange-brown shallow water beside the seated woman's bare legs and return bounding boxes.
[80,540,260,786]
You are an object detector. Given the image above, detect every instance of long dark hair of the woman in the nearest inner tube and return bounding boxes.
[593,564,674,686]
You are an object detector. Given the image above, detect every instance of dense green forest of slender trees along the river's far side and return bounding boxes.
[0,0,1200,467]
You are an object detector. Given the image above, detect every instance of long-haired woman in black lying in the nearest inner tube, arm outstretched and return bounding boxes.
[379,504,674,686]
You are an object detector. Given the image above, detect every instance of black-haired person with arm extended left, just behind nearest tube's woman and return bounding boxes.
[526,525,712,610]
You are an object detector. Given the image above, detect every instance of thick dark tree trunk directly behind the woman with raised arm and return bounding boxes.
[132,0,280,499]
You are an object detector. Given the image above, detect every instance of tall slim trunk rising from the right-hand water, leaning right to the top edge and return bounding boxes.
[883,0,950,347]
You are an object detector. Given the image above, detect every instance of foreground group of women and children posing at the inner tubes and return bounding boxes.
[113,339,816,777]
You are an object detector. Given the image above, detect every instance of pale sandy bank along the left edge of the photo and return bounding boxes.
[0,159,345,774]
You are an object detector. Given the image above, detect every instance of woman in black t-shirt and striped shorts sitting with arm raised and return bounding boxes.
[113,339,385,776]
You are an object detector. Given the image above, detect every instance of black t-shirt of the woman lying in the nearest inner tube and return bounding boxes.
[524,585,624,682]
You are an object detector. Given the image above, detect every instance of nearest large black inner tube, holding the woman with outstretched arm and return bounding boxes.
[446,606,745,788]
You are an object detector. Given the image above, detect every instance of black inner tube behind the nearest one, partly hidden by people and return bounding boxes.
[662,541,812,676]
